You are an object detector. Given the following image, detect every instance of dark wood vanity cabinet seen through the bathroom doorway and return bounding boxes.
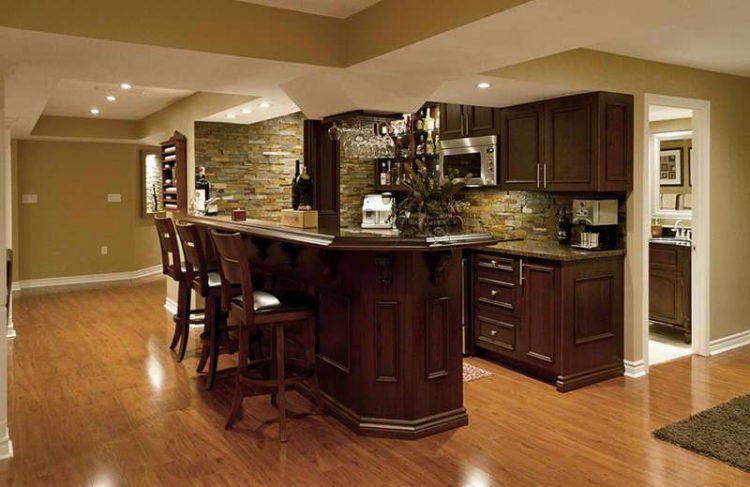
[648,242,692,343]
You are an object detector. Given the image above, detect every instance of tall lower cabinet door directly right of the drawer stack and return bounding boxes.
[519,263,557,369]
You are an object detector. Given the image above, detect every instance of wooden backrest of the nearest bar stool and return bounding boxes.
[211,230,255,328]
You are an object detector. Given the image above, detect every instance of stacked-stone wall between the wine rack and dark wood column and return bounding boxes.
[195,112,304,220]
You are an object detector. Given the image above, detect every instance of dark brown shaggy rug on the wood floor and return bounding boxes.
[654,394,750,472]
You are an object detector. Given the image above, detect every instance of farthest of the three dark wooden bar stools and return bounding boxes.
[154,217,204,362]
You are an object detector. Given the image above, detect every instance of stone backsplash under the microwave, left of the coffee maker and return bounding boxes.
[462,188,574,240]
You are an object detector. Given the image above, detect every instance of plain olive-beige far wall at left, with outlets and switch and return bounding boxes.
[15,140,160,280]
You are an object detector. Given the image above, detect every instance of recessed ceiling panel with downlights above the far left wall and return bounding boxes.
[43,79,194,120]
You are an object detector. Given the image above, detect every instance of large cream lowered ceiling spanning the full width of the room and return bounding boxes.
[0,0,750,137]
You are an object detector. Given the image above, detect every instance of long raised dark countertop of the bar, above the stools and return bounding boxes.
[174,213,498,251]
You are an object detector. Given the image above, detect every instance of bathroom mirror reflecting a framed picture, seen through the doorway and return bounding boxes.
[650,130,693,220]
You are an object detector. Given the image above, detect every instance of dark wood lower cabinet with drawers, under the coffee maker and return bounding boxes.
[472,251,624,392]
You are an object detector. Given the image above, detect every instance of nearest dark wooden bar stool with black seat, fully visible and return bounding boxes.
[211,230,323,442]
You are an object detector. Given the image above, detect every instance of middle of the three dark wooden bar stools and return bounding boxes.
[176,222,240,390]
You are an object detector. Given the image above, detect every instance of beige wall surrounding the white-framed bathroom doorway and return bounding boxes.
[490,49,750,350]
